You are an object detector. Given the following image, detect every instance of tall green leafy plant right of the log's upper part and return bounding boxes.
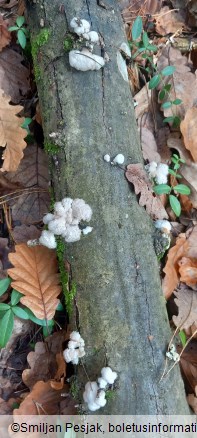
[129,16,182,127]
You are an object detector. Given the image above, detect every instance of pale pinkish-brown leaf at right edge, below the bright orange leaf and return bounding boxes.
[172,284,197,330]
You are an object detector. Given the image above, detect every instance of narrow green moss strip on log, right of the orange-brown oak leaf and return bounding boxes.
[56,237,77,317]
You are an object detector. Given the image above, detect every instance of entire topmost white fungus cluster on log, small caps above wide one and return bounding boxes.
[69,17,105,71]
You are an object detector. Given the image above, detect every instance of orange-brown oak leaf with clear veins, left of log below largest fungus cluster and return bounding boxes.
[8,243,61,320]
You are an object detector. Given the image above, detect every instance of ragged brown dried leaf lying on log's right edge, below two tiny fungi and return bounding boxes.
[125,163,168,219]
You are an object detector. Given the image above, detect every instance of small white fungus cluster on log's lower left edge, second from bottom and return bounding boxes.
[63,332,85,365]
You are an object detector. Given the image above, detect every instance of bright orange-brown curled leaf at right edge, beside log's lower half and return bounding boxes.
[162,226,197,299]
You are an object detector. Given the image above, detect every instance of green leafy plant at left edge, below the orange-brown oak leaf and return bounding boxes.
[0,278,63,348]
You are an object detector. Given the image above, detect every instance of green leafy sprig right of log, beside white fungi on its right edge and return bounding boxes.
[154,154,190,216]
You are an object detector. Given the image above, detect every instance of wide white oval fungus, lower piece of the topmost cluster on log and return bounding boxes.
[69,48,105,71]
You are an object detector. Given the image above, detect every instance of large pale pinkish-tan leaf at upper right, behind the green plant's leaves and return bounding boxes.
[157,46,197,119]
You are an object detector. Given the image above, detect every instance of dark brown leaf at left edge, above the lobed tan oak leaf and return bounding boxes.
[0,47,30,103]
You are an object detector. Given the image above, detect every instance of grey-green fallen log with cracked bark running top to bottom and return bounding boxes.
[28,0,189,414]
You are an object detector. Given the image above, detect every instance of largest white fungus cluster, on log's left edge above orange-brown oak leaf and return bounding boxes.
[39,198,92,248]
